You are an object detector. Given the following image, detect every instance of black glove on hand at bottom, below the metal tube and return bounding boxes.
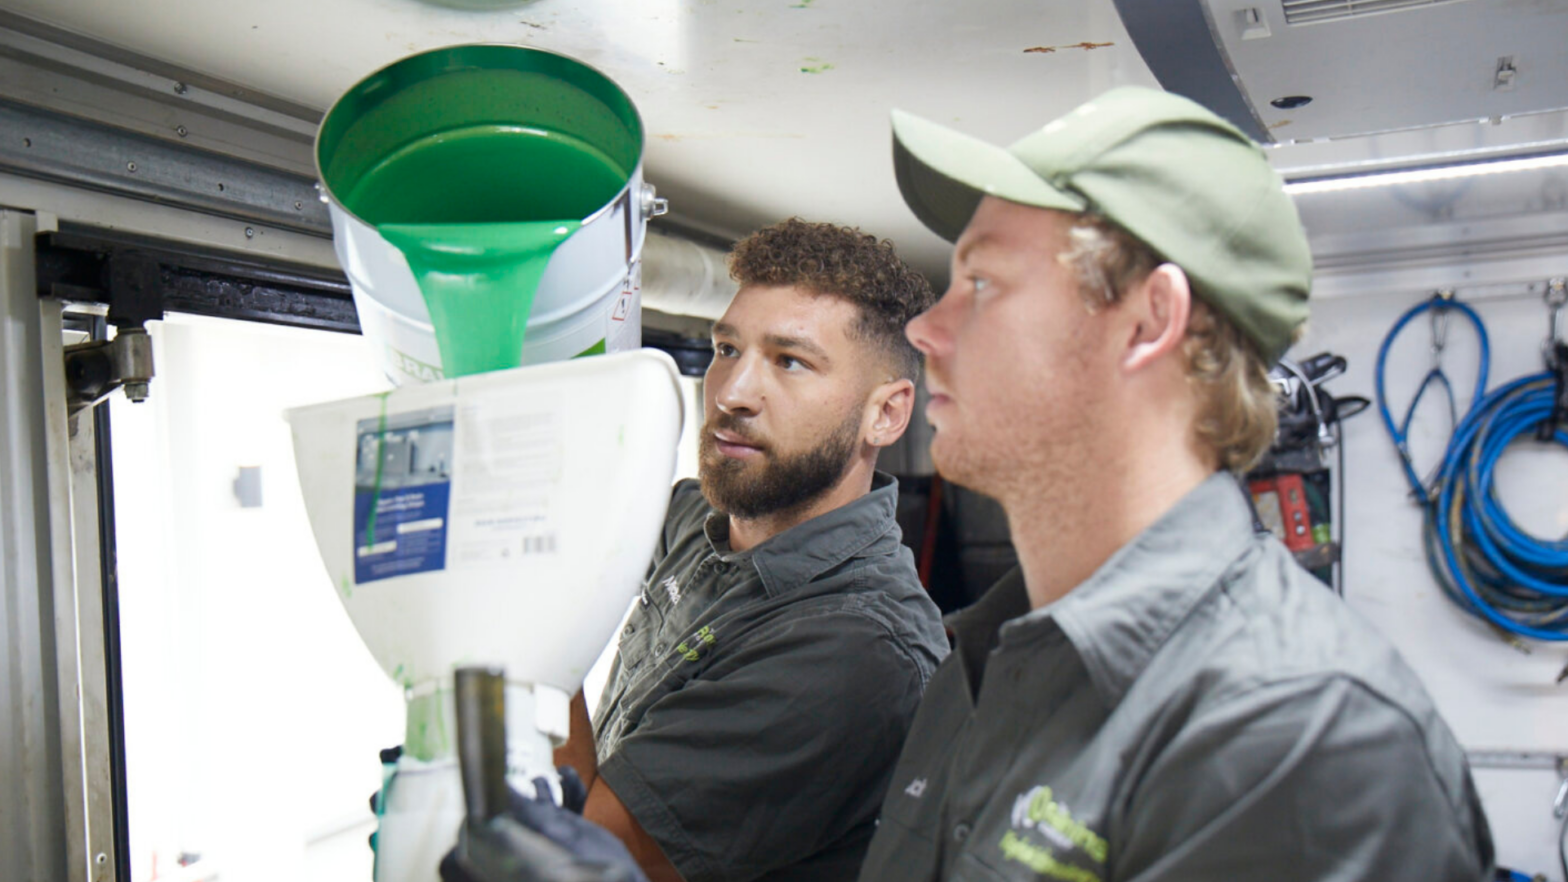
[441,767,648,882]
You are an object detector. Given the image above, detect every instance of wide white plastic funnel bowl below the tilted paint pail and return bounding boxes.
[287,350,682,703]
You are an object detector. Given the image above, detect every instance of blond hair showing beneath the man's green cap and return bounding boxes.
[1058,215,1279,474]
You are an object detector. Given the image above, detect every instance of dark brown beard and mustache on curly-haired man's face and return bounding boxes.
[698,410,861,519]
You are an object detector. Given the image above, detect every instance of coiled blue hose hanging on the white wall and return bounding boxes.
[1377,298,1568,640]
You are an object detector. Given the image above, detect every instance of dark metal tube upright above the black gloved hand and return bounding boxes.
[456,667,511,824]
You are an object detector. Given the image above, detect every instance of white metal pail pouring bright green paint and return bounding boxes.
[315,44,663,385]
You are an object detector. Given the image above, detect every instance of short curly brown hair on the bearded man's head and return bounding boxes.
[729,218,936,380]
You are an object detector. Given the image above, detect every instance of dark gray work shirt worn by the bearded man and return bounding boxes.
[594,474,947,882]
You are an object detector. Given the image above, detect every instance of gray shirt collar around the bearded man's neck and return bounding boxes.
[702,472,898,596]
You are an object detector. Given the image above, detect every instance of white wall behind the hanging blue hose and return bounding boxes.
[1295,292,1568,880]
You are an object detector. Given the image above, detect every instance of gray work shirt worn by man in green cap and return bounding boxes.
[861,474,1493,882]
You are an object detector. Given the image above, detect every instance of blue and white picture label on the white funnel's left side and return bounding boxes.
[354,405,453,585]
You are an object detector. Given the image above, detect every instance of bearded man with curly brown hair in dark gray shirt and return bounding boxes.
[557,220,947,882]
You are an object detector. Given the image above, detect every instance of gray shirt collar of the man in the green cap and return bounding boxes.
[1002,472,1254,706]
